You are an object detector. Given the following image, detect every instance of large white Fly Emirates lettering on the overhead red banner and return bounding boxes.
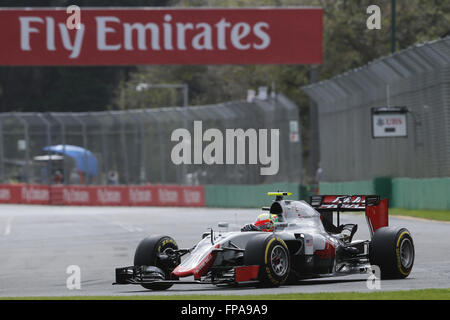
[19,14,271,59]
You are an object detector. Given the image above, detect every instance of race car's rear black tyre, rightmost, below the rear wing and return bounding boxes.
[369,227,415,279]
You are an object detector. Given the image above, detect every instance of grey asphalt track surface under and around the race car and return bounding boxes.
[0,205,450,297]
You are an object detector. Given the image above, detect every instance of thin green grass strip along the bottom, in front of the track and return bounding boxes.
[0,289,450,300]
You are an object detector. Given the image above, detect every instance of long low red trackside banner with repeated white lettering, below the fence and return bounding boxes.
[0,184,205,207]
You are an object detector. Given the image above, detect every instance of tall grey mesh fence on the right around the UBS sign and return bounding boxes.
[302,37,450,182]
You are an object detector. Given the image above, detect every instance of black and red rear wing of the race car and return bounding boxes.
[310,195,389,236]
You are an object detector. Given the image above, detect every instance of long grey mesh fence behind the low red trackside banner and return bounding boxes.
[0,94,302,185]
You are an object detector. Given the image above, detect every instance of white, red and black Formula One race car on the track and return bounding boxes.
[114,192,415,290]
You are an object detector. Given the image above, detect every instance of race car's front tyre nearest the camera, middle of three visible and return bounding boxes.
[244,234,291,287]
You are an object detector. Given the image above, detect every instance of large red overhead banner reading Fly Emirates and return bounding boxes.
[0,8,322,65]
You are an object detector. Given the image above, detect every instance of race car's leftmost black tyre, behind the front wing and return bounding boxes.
[134,235,179,290]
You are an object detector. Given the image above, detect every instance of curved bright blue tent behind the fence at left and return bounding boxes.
[43,144,98,176]
